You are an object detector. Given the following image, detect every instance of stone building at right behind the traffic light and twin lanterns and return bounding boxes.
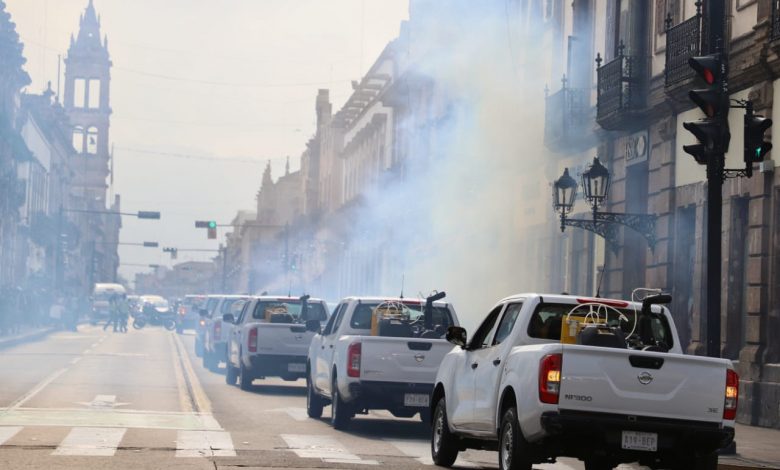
[531,0,780,427]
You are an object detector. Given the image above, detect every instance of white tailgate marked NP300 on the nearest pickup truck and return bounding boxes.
[559,345,728,422]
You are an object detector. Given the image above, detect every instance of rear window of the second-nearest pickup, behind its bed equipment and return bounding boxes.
[349,302,453,338]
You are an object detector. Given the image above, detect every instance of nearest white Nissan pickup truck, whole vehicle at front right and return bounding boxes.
[431,294,739,470]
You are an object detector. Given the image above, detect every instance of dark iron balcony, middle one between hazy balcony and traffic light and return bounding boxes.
[596,43,645,131]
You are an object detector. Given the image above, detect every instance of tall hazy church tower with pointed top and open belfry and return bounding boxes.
[64,0,111,208]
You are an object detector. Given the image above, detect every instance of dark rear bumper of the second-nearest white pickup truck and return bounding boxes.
[348,381,433,412]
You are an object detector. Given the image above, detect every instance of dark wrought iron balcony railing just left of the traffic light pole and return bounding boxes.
[665,2,702,88]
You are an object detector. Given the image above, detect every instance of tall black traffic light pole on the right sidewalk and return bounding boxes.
[706,0,728,357]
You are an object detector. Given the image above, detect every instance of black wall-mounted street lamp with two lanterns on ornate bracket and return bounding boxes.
[553,157,658,253]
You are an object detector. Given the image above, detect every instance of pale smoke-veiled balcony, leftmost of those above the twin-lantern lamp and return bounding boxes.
[544,75,593,153]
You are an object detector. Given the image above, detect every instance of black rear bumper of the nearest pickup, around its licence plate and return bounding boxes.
[541,411,734,458]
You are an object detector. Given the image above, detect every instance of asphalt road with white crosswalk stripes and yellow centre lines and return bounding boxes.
[0,326,624,470]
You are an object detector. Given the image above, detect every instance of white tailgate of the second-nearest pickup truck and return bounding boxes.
[360,336,452,384]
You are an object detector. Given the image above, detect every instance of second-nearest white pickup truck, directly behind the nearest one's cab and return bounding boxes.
[306,293,458,429]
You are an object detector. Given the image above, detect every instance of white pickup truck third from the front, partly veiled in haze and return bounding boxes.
[222,295,328,390]
